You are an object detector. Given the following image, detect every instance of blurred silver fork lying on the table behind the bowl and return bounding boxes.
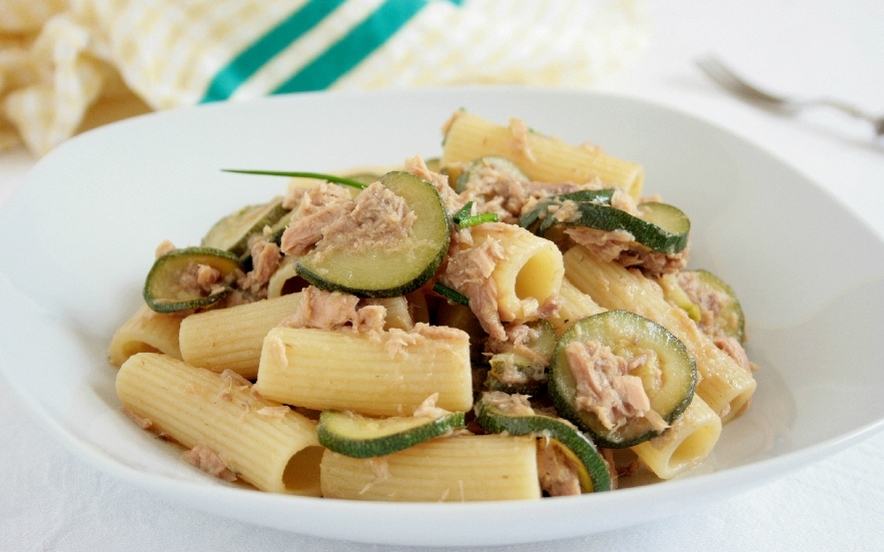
[697,57,884,136]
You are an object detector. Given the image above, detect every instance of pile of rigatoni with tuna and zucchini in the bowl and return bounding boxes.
[109,111,756,501]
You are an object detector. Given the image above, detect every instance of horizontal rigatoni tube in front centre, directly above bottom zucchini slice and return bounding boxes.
[255,324,473,416]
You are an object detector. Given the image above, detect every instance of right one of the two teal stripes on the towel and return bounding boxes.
[273,0,432,94]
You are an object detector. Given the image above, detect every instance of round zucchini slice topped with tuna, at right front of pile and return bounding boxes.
[547,310,697,448]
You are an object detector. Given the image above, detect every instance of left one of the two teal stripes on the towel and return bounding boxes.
[202,0,346,102]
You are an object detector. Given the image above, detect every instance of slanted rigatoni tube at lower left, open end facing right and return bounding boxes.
[116,353,323,496]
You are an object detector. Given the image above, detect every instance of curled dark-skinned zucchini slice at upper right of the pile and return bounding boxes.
[536,201,691,253]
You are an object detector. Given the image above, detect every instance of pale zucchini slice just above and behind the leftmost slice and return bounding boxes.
[200,197,289,257]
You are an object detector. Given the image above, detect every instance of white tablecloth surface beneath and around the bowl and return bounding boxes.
[0,0,884,552]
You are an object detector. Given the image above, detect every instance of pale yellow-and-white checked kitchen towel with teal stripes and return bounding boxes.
[0,0,648,155]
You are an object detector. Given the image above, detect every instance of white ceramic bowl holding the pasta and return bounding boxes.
[0,88,884,546]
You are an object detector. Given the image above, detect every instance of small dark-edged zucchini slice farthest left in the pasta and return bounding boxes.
[142,247,242,313]
